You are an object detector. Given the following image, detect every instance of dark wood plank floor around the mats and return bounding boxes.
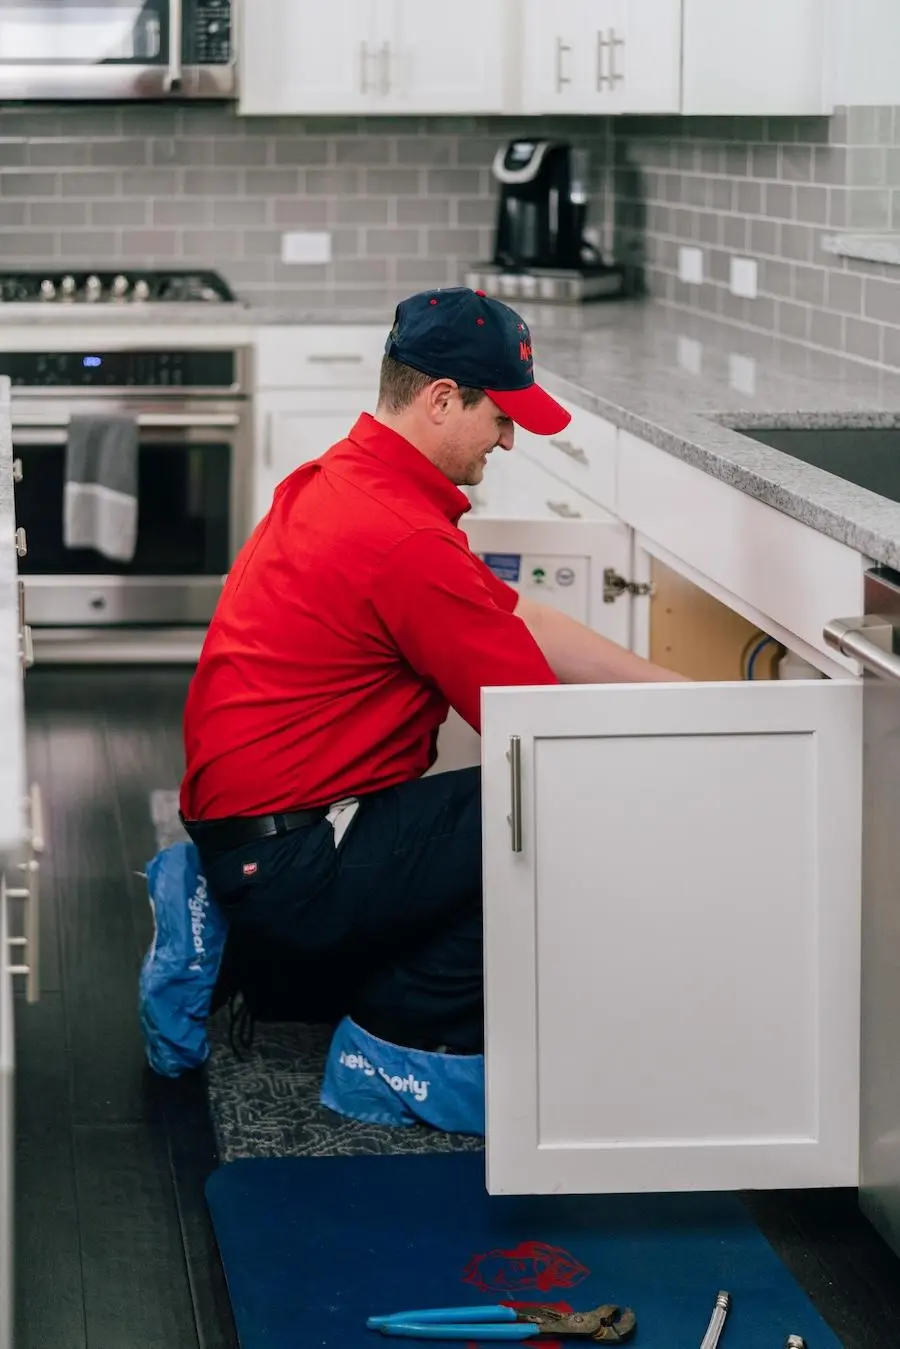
[16,669,900,1349]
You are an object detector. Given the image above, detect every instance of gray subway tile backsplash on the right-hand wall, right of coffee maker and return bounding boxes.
[613,107,900,366]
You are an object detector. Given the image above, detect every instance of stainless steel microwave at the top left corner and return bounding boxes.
[0,0,236,101]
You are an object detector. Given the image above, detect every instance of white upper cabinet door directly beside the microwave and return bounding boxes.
[237,0,381,116]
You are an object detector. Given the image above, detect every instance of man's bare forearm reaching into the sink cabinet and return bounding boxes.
[515,596,690,684]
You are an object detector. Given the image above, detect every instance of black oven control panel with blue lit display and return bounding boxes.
[0,351,237,390]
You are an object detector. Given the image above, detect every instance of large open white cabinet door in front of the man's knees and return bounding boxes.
[482,680,862,1194]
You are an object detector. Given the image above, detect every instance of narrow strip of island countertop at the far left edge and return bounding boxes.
[0,376,26,866]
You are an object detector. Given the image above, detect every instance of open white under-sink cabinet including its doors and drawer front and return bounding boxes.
[447,396,865,1194]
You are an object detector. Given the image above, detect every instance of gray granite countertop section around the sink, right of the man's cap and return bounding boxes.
[512,301,900,569]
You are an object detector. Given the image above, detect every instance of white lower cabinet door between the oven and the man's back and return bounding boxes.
[251,390,374,529]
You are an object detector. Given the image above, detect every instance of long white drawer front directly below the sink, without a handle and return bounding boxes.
[618,432,865,672]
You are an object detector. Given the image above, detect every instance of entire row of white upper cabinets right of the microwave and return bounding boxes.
[239,0,831,116]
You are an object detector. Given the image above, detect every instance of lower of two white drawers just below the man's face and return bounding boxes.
[466,449,613,521]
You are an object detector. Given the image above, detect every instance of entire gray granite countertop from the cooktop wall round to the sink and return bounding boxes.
[0,290,900,569]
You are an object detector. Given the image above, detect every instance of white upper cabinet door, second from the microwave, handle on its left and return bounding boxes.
[379,0,517,113]
